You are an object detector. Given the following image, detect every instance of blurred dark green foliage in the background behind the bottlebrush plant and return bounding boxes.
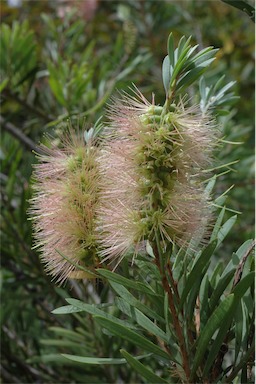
[0,0,254,383]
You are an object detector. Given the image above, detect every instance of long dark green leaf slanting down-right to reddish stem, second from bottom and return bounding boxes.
[94,316,170,359]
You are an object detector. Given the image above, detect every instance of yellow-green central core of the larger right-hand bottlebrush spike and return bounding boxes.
[135,106,178,218]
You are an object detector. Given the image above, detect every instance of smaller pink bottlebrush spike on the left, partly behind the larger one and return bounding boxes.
[30,133,99,283]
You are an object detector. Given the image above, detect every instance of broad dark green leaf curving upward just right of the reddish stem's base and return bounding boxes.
[192,294,235,376]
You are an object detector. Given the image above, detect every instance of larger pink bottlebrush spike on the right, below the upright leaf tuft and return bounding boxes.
[97,89,215,265]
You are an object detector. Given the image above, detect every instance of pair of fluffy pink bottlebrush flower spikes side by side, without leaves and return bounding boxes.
[31,89,216,282]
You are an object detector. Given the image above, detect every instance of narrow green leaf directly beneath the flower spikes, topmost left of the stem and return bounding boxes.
[97,269,158,296]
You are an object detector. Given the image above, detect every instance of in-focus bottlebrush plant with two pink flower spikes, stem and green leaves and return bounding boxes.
[32,34,254,383]
